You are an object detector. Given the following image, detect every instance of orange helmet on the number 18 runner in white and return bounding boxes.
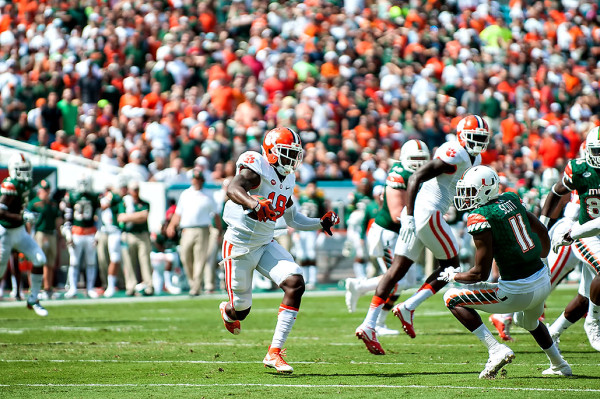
[263,127,304,176]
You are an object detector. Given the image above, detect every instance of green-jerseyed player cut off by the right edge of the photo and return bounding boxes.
[540,126,600,351]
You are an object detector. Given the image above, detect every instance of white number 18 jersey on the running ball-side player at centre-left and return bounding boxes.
[223,151,296,247]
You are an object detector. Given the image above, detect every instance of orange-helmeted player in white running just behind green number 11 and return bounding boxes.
[356,115,490,355]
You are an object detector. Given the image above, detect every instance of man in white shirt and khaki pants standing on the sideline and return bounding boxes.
[167,168,222,296]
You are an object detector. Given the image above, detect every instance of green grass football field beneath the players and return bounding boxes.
[0,289,600,398]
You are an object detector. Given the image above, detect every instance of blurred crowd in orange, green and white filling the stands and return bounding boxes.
[0,0,600,187]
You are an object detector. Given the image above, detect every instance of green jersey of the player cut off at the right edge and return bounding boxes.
[563,159,600,224]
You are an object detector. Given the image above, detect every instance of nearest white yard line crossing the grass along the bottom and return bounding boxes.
[0,384,600,392]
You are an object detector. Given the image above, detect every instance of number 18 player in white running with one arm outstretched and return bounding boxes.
[219,127,339,373]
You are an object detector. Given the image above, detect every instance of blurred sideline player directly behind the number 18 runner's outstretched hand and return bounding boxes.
[295,182,327,290]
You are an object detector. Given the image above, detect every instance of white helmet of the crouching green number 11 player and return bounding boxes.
[454,166,500,211]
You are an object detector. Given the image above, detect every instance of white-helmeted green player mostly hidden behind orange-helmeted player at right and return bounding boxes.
[345,140,431,335]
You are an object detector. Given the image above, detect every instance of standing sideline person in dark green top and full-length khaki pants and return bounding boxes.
[117,180,154,296]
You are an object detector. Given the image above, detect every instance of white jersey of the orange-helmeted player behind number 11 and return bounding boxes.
[415,141,481,219]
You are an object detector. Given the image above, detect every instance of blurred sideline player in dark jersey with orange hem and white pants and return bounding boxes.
[61,175,100,299]
